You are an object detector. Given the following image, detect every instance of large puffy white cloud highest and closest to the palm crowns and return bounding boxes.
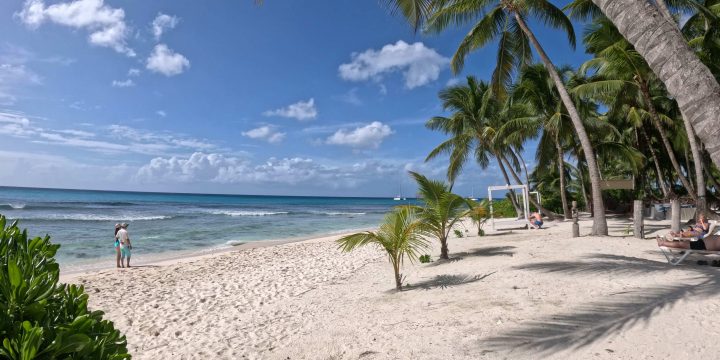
[338,40,450,91]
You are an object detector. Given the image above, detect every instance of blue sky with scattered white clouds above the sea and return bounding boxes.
[0,0,587,196]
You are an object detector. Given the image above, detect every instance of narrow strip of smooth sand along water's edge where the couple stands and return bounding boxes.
[60,228,376,282]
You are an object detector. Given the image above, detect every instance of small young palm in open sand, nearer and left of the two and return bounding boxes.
[336,206,429,290]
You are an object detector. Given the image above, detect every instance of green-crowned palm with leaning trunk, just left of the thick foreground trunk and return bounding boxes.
[573,17,704,201]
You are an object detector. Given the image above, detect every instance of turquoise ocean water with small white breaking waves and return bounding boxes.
[0,187,412,266]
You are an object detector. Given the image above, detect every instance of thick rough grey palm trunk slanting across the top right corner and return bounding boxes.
[592,0,720,174]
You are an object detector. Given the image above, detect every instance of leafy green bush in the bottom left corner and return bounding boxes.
[0,215,130,360]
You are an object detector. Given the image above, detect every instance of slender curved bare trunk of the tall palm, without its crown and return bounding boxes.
[513,12,608,235]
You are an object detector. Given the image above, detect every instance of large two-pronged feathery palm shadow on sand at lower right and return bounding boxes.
[480,254,720,356]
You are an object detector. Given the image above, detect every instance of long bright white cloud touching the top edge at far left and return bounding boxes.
[15,0,135,57]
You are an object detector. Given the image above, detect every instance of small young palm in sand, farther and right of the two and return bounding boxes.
[410,171,473,259]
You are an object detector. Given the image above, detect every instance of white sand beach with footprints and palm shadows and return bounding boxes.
[61,219,720,359]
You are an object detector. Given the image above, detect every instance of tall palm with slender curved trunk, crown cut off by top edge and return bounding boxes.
[387,0,607,235]
